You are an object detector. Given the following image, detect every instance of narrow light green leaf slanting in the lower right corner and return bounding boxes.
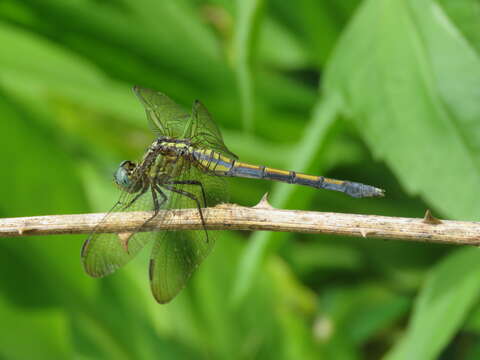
[385,248,480,360]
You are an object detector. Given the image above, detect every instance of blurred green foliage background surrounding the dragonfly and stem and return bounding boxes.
[0,0,480,360]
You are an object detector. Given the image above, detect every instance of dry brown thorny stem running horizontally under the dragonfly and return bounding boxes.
[0,199,480,245]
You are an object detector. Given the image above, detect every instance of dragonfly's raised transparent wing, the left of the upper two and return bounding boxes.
[133,86,190,138]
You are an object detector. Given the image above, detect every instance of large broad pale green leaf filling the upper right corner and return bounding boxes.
[325,0,480,219]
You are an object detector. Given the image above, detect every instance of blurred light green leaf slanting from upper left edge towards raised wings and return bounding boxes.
[0,23,145,124]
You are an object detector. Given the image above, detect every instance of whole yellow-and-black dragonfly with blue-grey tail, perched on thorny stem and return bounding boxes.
[81,86,384,304]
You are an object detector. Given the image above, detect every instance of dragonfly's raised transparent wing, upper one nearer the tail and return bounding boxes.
[188,100,238,159]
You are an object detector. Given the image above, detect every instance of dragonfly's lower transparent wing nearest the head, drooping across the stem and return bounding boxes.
[81,191,155,277]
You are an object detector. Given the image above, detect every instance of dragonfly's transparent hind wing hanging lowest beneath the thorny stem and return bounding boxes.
[150,166,228,303]
